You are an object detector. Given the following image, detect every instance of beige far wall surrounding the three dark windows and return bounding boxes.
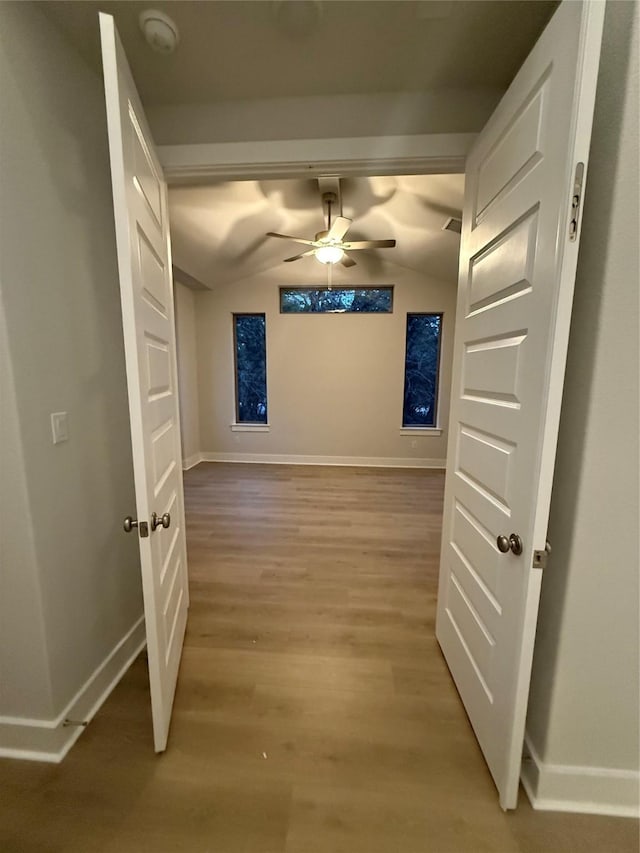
[196,261,456,464]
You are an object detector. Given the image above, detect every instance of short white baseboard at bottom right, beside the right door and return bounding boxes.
[521,735,640,818]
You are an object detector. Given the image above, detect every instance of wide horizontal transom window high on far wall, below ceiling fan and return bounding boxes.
[280,286,393,314]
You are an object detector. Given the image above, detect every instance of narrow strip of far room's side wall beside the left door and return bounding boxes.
[173,278,201,467]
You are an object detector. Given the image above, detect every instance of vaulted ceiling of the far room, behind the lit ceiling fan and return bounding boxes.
[169,175,464,287]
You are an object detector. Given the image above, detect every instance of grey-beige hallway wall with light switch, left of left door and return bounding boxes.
[0,3,142,752]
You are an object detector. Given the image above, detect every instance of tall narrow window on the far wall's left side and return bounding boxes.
[233,314,267,424]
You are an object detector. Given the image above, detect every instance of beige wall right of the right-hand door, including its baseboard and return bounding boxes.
[527,3,640,810]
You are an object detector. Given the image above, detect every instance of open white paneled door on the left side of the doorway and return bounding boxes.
[100,13,189,752]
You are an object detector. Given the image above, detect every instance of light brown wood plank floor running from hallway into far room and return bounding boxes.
[0,463,638,853]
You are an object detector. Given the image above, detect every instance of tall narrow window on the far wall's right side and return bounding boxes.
[402,314,442,427]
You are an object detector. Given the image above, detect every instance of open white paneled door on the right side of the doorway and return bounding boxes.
[436,0,604,809]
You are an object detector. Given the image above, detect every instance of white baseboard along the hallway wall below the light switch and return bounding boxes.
[0,616,146,764]
